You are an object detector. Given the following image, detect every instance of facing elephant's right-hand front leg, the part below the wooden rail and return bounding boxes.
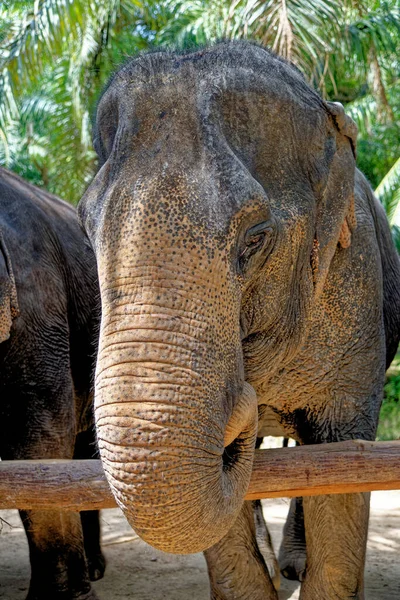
[300,493,370,600]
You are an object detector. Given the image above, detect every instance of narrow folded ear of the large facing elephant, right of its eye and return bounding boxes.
[311,102,357,296]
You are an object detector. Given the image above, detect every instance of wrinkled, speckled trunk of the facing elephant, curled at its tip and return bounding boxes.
[95,205,257,553]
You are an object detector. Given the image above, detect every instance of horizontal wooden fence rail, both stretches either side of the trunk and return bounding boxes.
[0,440,400,510]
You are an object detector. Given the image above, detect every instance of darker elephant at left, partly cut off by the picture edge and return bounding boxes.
[0,169,105,600]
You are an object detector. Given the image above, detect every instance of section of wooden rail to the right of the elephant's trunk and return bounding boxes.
[246,440,400,500]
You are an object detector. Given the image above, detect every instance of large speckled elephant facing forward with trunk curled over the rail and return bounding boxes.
[78,41,400,600]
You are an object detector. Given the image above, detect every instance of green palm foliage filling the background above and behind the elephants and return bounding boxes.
[0,0,400,210]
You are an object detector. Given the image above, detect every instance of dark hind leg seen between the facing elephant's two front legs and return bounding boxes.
[279,498,306,581]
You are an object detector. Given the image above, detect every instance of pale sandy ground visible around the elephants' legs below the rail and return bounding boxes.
[0,491,400,600]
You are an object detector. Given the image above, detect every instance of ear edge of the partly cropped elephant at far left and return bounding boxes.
[0,231,19,343]
